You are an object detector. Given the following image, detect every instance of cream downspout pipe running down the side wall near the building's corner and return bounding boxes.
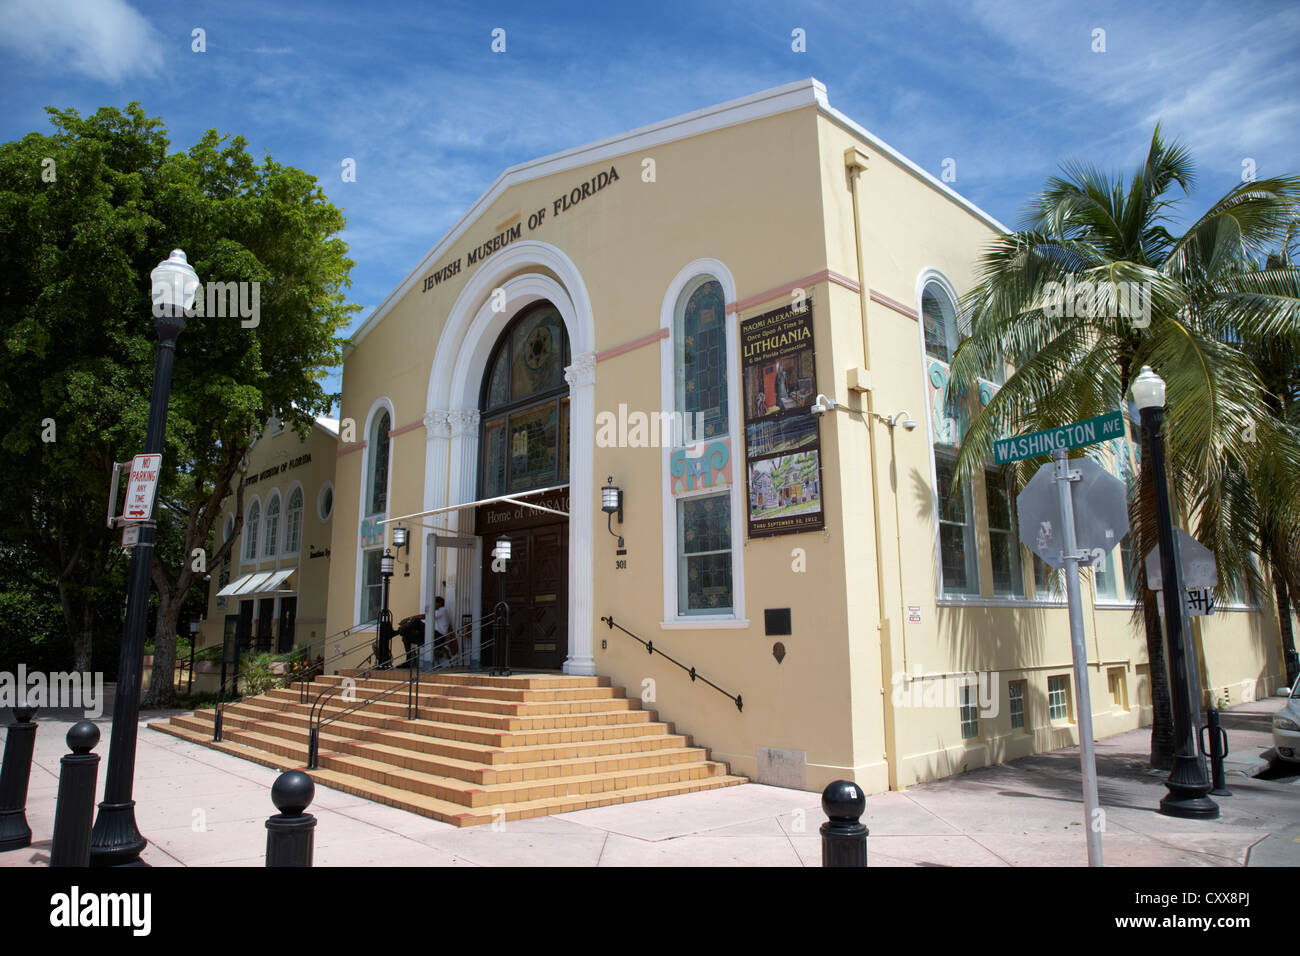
[844,146,898,790]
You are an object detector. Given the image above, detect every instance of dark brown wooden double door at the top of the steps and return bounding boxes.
[482,522,568,670]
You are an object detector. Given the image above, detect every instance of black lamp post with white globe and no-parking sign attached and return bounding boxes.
[90,248,199,866]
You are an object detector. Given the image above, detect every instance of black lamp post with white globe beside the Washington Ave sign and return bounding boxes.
[1132,365,1219,819]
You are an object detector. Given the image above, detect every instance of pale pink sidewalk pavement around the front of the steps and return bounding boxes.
[0,698,1300,866]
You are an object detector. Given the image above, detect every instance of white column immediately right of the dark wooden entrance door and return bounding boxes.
[564,351,595,675]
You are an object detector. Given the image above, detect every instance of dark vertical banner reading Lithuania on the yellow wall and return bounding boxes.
[740,297,826,537]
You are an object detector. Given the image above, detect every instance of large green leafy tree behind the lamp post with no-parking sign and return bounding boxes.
[0,103,358,702]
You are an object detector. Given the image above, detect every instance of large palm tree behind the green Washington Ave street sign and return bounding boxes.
[952,126,1300,766]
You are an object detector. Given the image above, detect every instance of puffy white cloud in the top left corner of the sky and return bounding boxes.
[0,0,163,83]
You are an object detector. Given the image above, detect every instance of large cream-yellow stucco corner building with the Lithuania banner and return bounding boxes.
[200,79,1283,792]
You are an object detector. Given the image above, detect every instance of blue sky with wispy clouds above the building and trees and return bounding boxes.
[0,0,1300,403]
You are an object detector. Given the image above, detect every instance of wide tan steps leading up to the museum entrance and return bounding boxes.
[150,672,744,826]
